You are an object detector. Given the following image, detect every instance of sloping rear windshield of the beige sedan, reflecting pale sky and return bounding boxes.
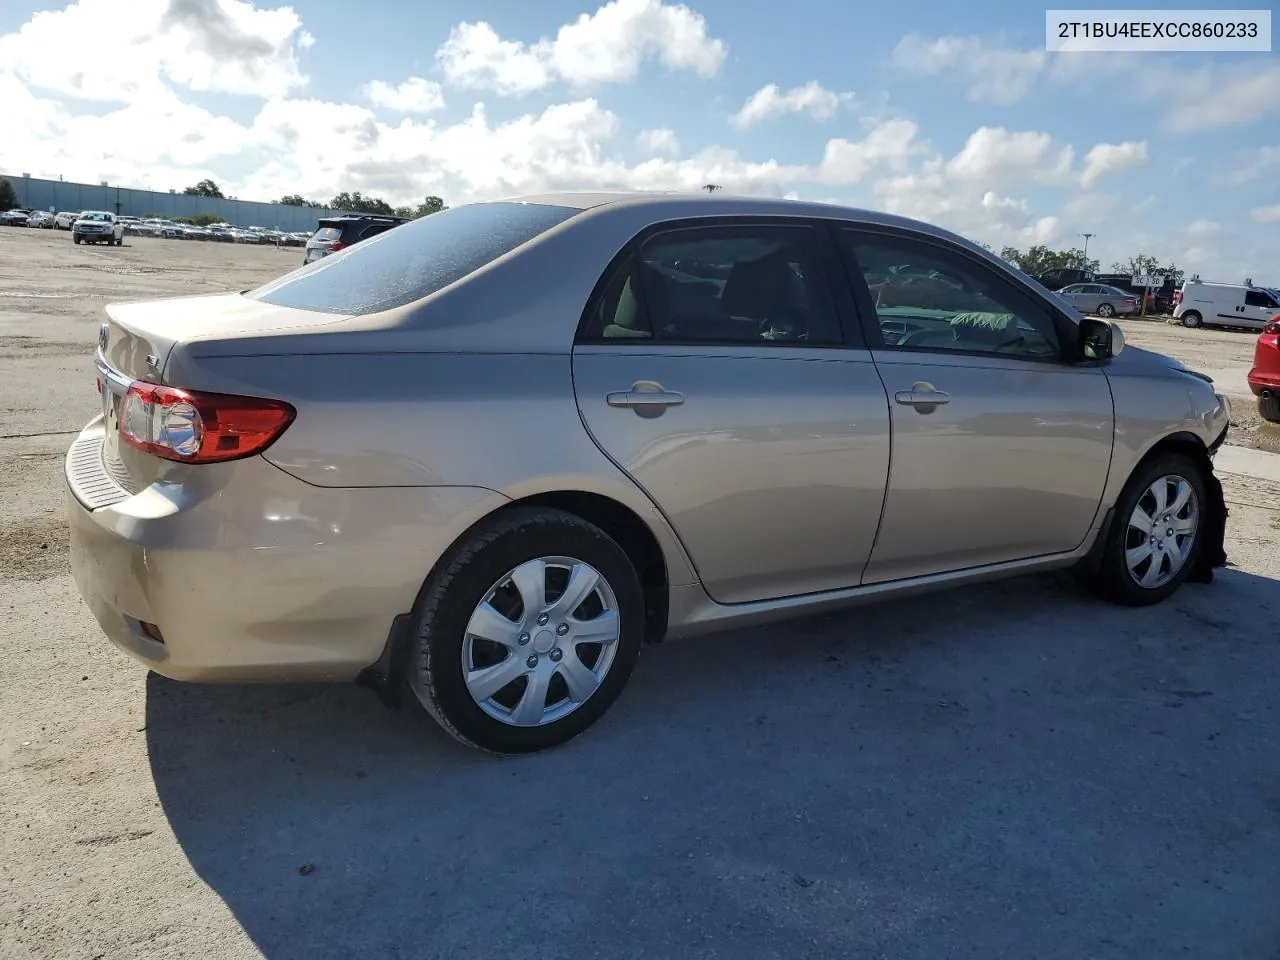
[246,202,579,316]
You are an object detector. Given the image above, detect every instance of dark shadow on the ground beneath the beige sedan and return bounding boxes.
[146,570,1280,960]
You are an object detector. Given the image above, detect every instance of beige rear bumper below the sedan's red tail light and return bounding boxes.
[67,420,504,682]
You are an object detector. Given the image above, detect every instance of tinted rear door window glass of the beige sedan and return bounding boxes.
[586,225,841,346]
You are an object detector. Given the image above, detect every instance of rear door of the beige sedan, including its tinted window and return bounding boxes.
[573,219,890,603]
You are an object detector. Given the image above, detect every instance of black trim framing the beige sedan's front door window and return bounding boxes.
[831,220,1075,365]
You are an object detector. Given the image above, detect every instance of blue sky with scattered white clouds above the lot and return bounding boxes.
[0,0,1280,277]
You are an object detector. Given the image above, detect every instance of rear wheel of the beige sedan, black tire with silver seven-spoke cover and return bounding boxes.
[408,508,645,754]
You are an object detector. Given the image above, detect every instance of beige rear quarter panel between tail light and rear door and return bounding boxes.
[168,352,696,585]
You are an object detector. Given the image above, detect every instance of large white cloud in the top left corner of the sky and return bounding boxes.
[0,0,312,102]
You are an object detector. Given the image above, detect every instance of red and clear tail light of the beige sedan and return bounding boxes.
[119,380,297,463]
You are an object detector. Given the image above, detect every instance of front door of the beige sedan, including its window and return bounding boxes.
[841,230,1114,584]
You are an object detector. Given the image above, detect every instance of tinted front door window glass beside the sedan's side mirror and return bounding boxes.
[844,230,1060,361]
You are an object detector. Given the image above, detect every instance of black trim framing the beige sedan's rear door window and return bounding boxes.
[573,214,868,351]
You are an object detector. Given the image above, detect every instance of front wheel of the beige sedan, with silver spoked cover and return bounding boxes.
[1093,453,1210,607]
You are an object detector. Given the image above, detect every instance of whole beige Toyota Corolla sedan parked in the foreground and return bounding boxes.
[67,195,1229,753]
